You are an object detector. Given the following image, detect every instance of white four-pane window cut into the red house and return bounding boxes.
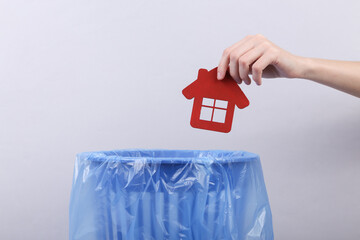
[200,98,228,123]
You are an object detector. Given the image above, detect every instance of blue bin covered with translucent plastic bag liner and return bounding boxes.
[70,150,273,240]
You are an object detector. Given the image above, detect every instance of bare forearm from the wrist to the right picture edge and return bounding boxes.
[299,58,360,97]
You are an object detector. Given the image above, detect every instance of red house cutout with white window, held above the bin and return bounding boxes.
[182,68,249,133]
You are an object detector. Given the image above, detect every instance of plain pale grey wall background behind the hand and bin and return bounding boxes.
[0,0,360,240]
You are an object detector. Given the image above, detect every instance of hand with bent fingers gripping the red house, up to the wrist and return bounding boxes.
[218,34,303,85]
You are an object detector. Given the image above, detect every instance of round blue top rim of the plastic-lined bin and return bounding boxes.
[77,148,259,164]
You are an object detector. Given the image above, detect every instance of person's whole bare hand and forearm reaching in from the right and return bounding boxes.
[218,34,360,97]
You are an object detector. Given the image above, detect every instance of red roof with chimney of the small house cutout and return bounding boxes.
[182,68,249,108]
